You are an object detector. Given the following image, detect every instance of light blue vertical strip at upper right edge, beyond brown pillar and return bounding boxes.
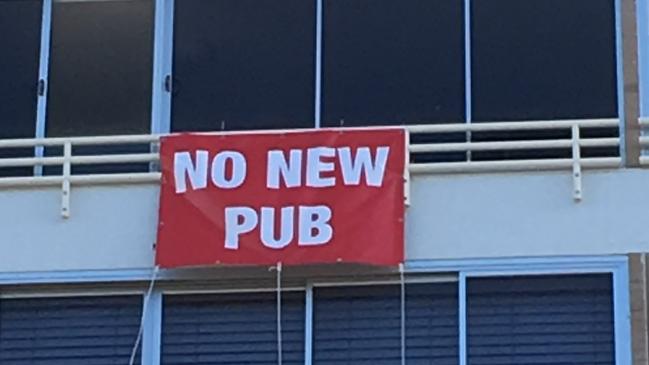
[636,0,649,117]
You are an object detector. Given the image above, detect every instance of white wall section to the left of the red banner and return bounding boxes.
[0,185,158,272]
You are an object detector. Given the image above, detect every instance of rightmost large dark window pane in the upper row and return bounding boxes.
[471,0,617,121]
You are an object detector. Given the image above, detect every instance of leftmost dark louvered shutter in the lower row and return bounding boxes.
[0,296,142,365]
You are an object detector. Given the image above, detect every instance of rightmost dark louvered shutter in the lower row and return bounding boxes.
[467,274,614,365]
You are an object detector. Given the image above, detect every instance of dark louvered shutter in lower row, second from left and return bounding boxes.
[162,292,305,365]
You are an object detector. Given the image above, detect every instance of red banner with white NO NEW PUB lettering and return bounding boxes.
[156,128,406,267]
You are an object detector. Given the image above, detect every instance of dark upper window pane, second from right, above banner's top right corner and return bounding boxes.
[322,0,465,126]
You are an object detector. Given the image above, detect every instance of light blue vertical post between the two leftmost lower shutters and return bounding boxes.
[142,290,162,365]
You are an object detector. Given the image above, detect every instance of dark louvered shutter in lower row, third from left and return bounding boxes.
[313,283,458,365]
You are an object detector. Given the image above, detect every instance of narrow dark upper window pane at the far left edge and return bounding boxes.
[0,0,43,176]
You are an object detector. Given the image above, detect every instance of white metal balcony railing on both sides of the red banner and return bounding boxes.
[0,119,620,216]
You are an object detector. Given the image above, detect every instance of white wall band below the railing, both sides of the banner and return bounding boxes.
[0,170,649,273]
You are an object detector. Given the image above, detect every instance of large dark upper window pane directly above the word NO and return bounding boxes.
[171,0,315,131]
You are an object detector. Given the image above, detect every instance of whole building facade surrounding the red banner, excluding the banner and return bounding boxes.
[0,0,649,365]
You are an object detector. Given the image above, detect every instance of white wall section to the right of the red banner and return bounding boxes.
[406,169,649,259]
